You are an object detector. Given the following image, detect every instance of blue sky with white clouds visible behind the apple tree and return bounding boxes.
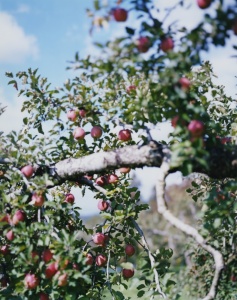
[0,0,237,216]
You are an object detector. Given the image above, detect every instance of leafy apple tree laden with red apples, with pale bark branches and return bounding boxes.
[0,0,237,300]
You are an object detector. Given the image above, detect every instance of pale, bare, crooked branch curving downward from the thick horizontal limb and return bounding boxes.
[156,160,224,300]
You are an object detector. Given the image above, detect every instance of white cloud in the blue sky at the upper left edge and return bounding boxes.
[0,12,39,63]
